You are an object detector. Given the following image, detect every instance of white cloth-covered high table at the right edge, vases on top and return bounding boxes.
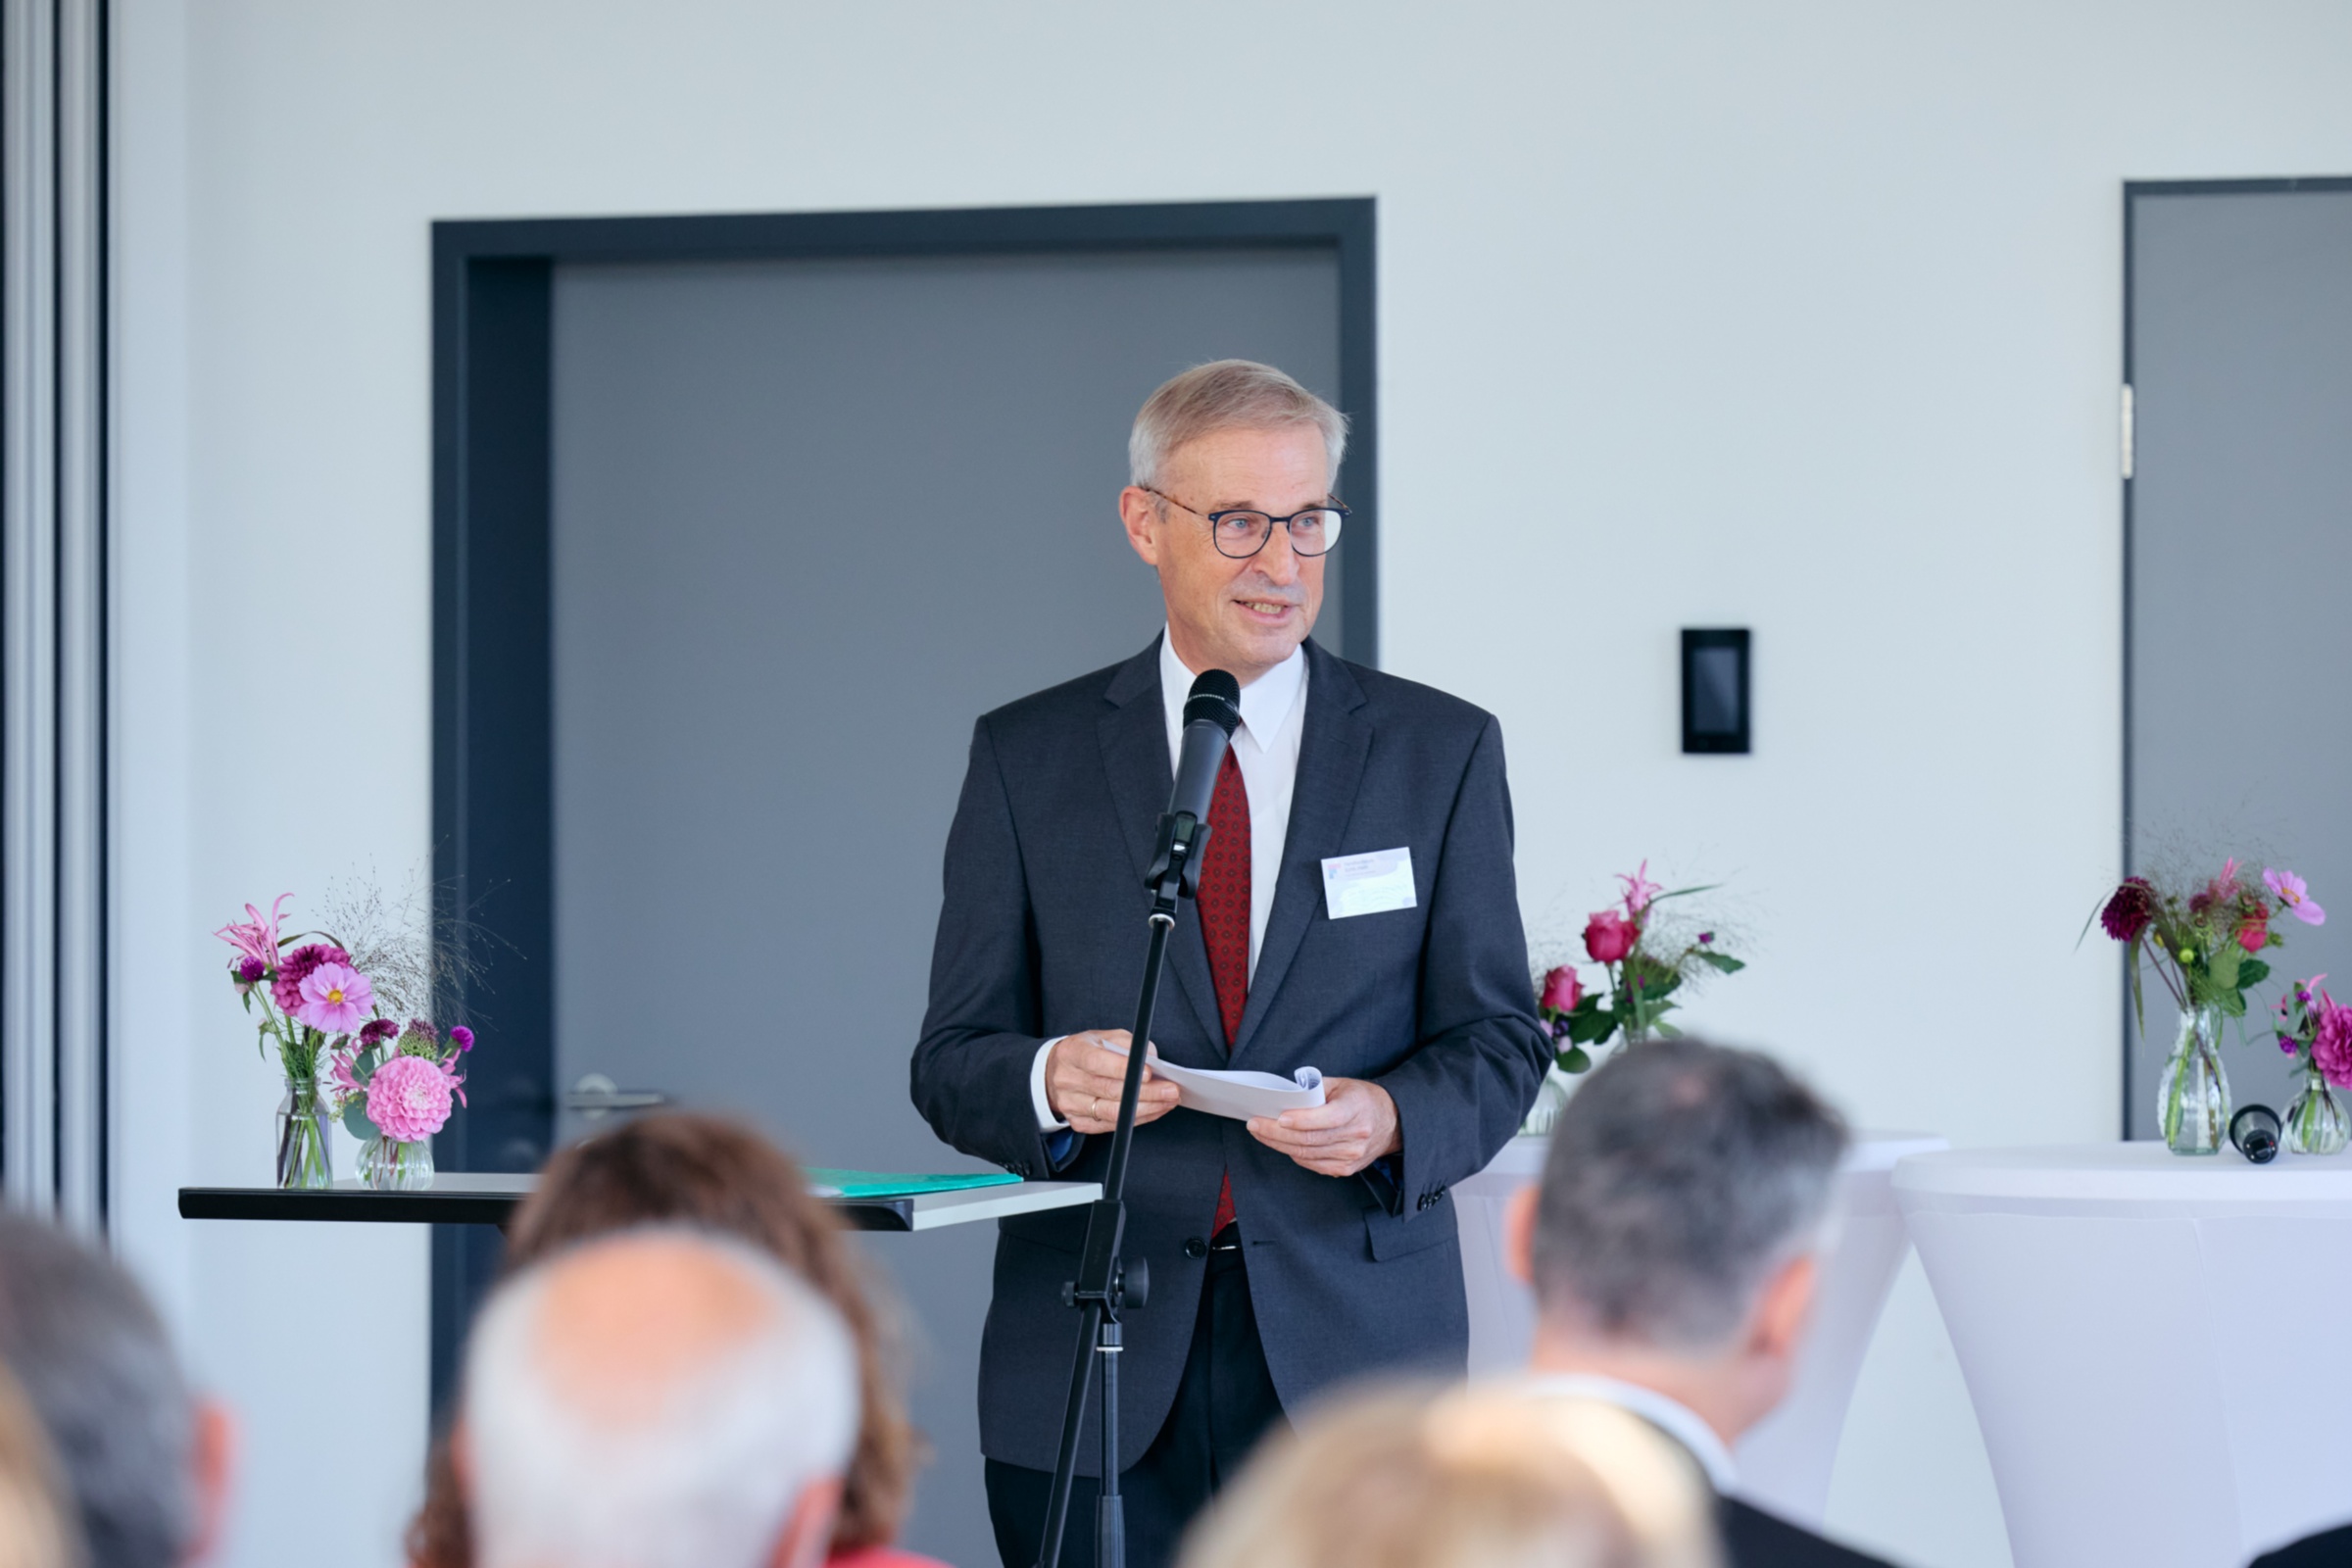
[1893,1143,2352,1568]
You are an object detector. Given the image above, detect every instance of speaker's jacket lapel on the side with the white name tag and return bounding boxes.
[1232,642,1371,1057]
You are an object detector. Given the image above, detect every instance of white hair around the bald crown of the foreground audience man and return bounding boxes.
[466,1227,858,1568]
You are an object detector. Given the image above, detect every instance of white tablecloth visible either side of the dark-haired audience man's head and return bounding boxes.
[1453,1133,1945,1526]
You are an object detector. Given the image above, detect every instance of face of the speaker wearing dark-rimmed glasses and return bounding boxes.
[1119,425,1331,686]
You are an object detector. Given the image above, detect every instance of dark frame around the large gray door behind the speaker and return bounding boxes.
[433,197,1381,1410]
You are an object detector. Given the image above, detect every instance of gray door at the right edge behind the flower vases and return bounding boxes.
[2135,181,2352,1138]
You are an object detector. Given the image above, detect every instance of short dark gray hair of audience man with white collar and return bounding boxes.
[1536,1039,1846,1349]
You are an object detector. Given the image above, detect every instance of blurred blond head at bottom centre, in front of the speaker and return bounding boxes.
[1183,1390,1719,1568]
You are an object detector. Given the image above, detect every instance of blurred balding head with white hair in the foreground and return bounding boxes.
[457,1230,858,1568]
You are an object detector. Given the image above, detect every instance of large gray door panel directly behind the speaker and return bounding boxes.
[553,249,1339,1566]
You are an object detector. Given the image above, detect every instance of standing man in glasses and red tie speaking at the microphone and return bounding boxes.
[912,360,1547,1568]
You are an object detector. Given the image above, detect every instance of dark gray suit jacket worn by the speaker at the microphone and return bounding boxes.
[912,642,1550,1474]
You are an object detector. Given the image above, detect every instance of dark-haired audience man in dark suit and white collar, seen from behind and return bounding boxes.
[1505,1039,1884,1568]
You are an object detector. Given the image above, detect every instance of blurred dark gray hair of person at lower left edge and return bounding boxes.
[0,1213,195,1568]
